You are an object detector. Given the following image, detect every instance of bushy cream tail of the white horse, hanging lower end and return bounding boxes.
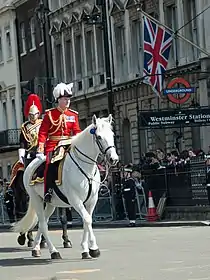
[12,198,38,234]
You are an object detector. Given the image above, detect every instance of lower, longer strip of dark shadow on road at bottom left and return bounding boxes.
[0,258,52,267]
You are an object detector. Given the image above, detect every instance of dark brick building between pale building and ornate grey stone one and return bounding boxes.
[15,0,53,111]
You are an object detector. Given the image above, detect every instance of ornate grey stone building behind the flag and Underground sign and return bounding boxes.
[49,0,210,163]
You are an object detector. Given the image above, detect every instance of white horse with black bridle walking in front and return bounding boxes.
[13,115,119,259]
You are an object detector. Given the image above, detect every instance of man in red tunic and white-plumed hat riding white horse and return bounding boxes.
[37,83,81,203]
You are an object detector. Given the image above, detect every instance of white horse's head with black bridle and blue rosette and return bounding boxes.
[90,115,119,165]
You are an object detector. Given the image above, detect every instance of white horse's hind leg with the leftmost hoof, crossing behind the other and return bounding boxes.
[32,204,55,257]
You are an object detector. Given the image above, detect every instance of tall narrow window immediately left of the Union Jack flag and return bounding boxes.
[131,20,142,74]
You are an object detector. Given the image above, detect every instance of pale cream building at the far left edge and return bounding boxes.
[0,0,22,179]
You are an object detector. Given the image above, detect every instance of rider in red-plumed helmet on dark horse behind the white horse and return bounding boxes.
[9,94,42,247]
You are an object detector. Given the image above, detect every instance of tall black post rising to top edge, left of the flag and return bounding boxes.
[83,0,114,115]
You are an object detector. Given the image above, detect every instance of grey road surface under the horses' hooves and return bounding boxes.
[0,226,210,280]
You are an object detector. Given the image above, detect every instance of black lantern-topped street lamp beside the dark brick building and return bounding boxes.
[35,0,53,108]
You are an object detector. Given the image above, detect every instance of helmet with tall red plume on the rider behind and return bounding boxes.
[24,94,42,118]
